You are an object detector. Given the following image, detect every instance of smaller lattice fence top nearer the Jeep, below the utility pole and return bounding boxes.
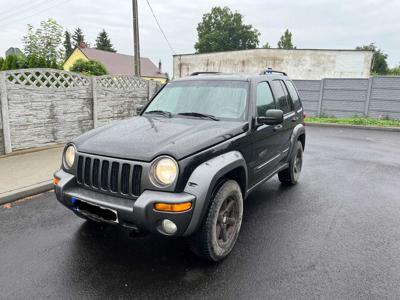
[96,75,148,90]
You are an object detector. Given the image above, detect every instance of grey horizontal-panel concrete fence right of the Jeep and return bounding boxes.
[294,76,400,119]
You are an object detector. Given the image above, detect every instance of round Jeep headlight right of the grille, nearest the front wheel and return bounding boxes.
[150,157,178,187]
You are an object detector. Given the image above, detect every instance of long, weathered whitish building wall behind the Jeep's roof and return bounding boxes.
[174,49,373,80]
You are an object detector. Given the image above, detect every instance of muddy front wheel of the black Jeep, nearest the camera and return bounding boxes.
[189,180,243,261]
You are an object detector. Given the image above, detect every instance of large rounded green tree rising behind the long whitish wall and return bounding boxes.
[194,7,260,53]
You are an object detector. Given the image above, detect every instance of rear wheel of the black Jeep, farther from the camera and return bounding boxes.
[278,141,303,185]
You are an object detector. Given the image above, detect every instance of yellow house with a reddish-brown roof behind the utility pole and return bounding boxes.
[63,45,168,83]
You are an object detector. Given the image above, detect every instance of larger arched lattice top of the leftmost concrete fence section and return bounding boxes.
[6,69,90,89]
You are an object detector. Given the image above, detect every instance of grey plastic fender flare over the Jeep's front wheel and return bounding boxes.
[184,151,248,236]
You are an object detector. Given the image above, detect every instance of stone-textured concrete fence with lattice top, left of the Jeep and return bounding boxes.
[0,69,161,155]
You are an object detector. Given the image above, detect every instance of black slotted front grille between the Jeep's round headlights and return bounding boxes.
[76,154,142,197]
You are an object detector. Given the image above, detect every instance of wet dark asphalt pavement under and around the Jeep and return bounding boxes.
[0,127,400,299]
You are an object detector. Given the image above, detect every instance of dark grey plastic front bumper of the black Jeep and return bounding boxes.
[54,170,196,236]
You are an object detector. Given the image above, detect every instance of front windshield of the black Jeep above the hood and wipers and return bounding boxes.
[144,80,248,120]
